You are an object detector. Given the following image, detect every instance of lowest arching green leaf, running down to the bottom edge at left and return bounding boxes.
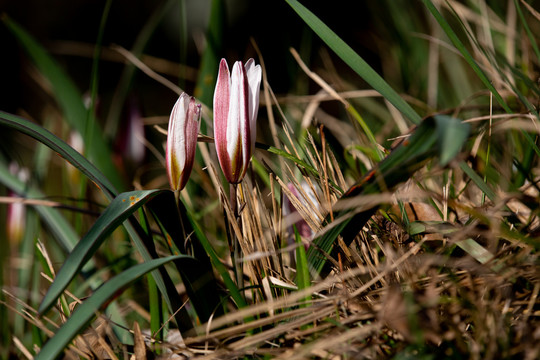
[34,255,190,360]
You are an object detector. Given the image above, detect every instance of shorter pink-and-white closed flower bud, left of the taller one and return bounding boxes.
[165,93,201,190]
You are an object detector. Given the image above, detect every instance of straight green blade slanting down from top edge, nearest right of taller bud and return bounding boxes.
[286,0,421,124]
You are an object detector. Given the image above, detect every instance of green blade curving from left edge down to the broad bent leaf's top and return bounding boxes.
[0,111,117,199]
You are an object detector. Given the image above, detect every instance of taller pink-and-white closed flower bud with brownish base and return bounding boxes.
[214,59,262,184]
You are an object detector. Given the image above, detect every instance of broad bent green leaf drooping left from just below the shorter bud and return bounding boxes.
[38,190,167,314]
